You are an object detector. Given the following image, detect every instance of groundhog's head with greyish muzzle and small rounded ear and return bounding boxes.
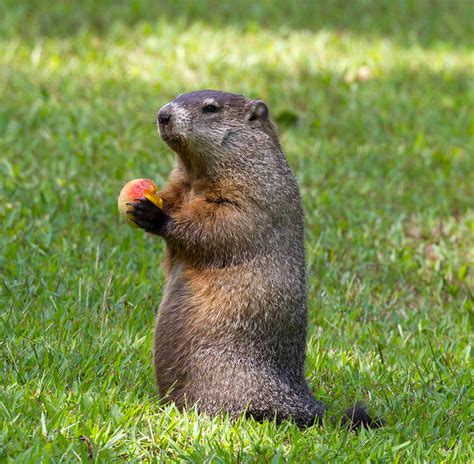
[157,90,278,171]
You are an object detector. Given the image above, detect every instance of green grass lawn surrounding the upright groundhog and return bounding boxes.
[0,0,474,463]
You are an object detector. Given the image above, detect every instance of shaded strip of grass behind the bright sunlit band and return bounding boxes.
[0,0,474,48]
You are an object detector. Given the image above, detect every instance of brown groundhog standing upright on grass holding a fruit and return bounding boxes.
[130,90,380,427]
